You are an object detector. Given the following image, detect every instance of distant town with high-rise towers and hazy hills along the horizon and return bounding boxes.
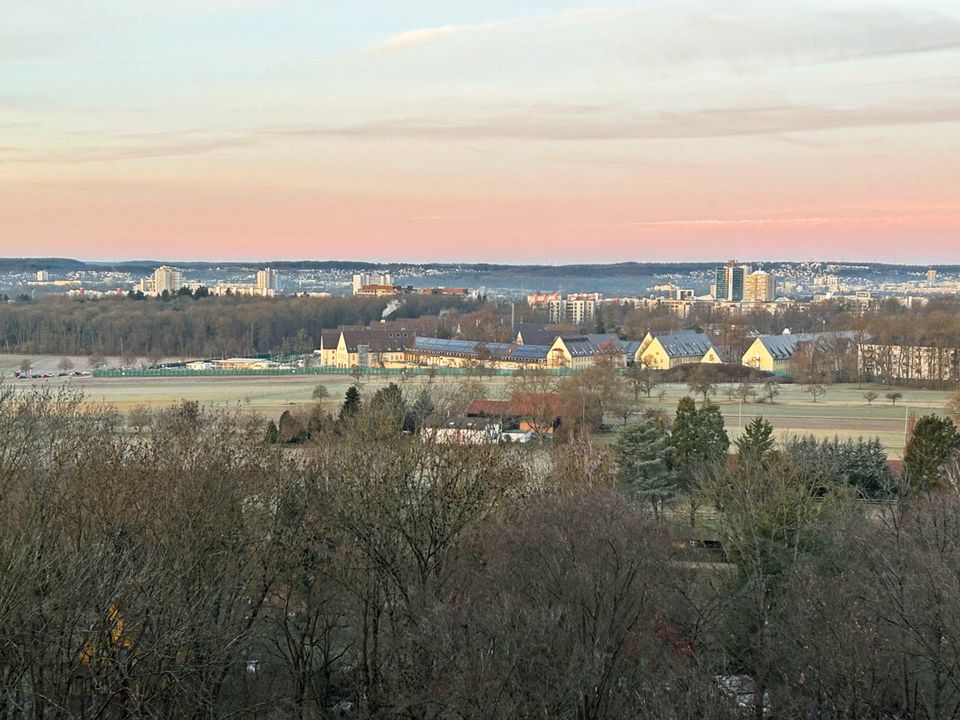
[0,259,960,308]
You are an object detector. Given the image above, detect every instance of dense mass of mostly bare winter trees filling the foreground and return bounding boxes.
[0,382,960,720]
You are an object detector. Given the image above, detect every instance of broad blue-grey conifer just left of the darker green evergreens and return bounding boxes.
[614,419,678,518]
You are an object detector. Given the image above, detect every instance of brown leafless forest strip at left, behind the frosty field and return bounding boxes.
[0,296,474,359]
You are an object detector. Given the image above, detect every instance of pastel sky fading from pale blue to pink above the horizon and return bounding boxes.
[0,0,960,264]
